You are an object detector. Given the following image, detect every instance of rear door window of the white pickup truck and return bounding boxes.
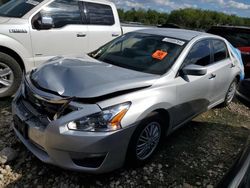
[85,2,115,25]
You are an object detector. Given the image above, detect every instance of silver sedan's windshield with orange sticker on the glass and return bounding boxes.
[89,33,186,75]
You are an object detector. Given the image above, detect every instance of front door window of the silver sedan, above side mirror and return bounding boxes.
[184,40,211,66]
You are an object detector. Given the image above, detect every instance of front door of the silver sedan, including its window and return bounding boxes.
[173,40,215,126]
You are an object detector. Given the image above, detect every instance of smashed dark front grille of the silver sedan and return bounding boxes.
[12,75,78,141]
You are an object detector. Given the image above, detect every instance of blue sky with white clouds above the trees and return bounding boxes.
[111,0,250,18]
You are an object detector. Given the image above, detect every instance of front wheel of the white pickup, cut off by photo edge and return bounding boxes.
[0,52,22,98]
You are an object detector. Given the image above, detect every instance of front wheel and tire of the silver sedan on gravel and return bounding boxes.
[126,113,166,167]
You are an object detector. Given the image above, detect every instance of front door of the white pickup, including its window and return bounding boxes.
[31,0,89,65]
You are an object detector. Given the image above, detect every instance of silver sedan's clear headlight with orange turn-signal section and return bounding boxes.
[68,102,131,132]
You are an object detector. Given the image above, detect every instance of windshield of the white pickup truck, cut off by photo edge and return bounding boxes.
[0,0,43,18]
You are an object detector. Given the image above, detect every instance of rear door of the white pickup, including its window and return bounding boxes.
[82,2,122,52]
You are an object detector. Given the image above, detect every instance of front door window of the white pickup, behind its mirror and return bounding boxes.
[33,0,83,29]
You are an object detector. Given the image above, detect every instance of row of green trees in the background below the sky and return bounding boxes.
[118,8,250,30]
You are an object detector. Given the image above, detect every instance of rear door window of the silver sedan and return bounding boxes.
[212,40,228,63]
